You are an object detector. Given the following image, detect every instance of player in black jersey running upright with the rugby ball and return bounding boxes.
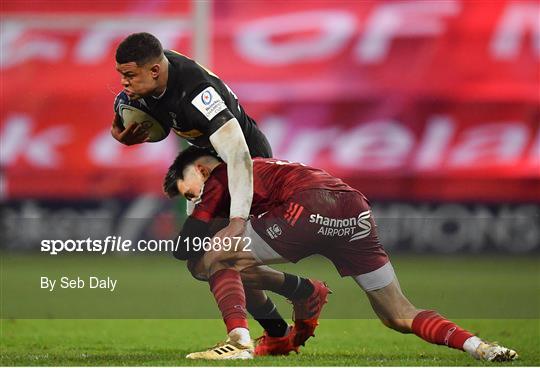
[111,33,304,354]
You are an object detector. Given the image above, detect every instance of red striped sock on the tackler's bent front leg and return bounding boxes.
[208,269,248,333]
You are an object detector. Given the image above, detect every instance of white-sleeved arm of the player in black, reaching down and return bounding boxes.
[210,118,253,238]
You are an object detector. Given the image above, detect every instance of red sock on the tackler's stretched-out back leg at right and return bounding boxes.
[412,310,474,350]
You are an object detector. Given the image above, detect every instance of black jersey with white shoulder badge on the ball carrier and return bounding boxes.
[114,50,272,157]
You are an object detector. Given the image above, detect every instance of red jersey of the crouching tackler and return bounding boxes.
[191,158,358,222]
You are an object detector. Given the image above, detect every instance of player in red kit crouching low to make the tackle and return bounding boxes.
[164,147,517,361]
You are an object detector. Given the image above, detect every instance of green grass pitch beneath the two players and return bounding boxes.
[0,255,540,366]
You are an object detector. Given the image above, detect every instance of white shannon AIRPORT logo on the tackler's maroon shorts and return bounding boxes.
[309,210,371,242]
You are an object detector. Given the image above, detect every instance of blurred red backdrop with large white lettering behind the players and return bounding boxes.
[0,0,540,202]
